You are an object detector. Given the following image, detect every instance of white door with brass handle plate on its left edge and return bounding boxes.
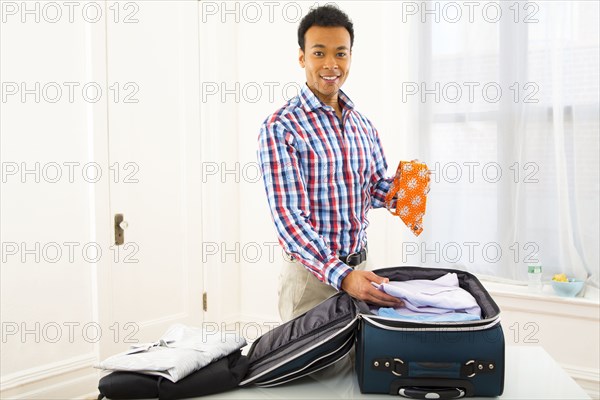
[99,1,203,357]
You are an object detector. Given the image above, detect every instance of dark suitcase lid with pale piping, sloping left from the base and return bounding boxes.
[240,292,359,386]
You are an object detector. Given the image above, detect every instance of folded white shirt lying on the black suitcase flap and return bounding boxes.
[94,324,246,382]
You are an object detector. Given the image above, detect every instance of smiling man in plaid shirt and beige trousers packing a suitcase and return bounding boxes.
[258,5,402,321]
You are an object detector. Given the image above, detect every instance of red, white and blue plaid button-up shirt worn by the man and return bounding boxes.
[258,84,392,290]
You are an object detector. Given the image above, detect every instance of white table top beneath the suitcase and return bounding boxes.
[198,346,590,400]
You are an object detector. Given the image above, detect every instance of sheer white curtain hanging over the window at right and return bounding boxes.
[390,1,600,286]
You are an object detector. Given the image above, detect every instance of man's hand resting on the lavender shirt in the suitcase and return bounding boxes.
[342,270,404,308]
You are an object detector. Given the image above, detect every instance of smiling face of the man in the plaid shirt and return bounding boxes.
[299,26,352,101]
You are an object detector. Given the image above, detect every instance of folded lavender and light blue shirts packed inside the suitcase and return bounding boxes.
[374,272,481,316]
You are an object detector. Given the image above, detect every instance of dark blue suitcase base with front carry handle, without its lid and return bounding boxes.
[356,267,504,399]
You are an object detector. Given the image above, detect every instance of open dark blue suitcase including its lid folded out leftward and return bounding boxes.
[240,267,504,399]
